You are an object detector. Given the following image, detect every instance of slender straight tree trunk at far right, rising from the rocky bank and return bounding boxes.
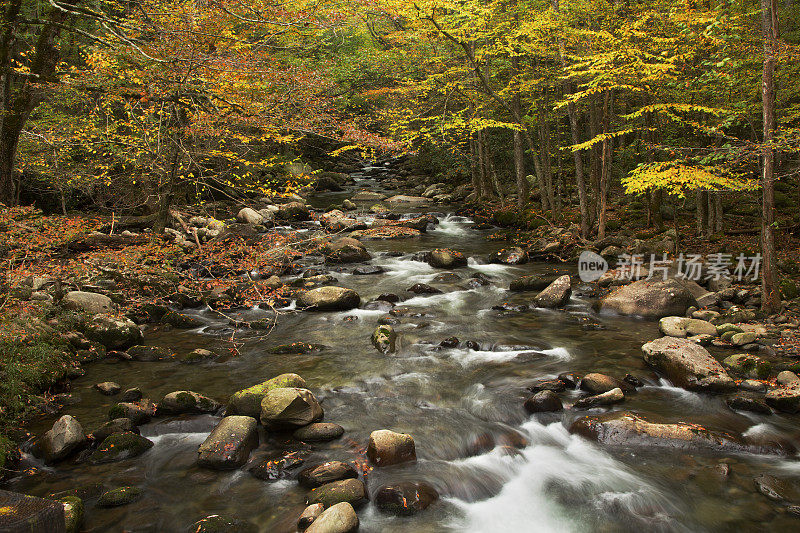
[761,0,781,314]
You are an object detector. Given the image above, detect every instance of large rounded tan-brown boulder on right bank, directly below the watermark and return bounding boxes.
[596,279,696,318]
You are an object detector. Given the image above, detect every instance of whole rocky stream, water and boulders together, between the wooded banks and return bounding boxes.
[7,162,800,533]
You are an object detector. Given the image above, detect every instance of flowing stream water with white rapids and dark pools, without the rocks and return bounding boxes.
[10,166,800,532]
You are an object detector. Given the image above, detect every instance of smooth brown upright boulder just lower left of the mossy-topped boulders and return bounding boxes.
[197,416,258,470]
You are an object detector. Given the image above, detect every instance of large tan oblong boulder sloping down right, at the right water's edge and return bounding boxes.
[642,337,736,392]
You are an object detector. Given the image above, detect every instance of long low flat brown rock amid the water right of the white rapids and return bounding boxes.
[569,411,788,455]
